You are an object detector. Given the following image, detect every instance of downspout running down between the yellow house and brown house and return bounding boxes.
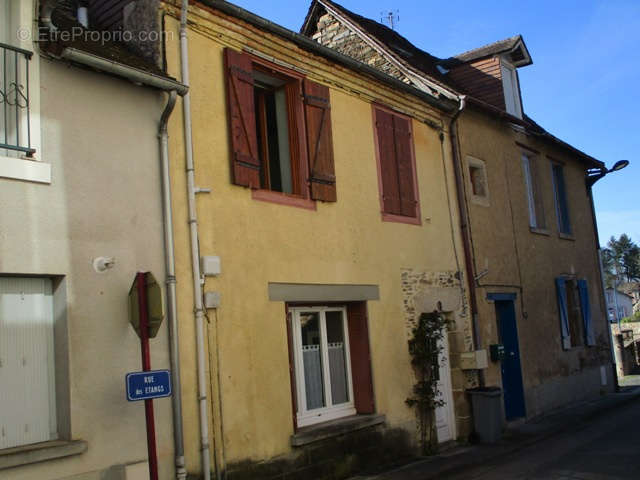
[449,95,485,387]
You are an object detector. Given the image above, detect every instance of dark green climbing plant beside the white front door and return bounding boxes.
[406,312,448,455]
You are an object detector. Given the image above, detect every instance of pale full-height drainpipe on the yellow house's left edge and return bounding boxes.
[180,0,211,480]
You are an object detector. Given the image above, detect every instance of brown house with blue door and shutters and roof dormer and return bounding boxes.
[301,0,614,420]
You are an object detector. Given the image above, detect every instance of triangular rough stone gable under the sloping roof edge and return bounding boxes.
[312,13,410,83]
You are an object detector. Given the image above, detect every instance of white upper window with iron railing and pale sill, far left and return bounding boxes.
[0,0,51,183]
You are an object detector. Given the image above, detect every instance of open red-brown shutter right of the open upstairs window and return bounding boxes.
[304,79,337,202]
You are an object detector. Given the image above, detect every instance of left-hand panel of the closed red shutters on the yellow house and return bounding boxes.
[375,109,402,215]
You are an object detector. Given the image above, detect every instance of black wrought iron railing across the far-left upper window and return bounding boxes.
[0,43,35,156]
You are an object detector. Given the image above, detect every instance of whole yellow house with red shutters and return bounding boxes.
[163,1,477,479]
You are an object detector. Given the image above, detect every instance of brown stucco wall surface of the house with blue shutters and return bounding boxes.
[460,110,612,416]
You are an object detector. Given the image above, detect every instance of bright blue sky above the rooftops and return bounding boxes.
[232,0,640,245]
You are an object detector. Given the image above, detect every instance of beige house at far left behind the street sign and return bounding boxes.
[0,0,186,480]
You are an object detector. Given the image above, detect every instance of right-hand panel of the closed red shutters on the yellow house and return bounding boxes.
[393,115,418,217]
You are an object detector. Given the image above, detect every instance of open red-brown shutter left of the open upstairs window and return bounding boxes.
[224,48,260,188]
